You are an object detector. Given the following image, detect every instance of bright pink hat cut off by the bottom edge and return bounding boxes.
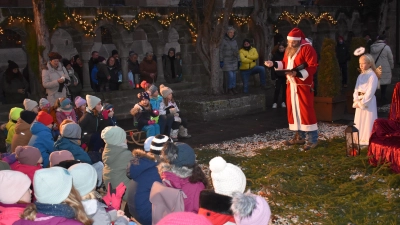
[157,212,212,225]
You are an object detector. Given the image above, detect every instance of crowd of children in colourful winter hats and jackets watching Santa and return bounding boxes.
[0,83,271,225]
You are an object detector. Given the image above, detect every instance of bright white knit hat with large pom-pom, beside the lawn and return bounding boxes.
[210,156,246,197]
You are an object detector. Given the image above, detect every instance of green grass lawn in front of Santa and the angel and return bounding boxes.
[196,138,400,225]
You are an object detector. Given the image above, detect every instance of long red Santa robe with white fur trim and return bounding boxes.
[277,39,318,131]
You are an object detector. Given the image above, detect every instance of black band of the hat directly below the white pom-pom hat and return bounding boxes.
[200,190,233,215]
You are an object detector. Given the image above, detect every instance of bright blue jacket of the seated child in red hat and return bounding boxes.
[28,121,54,168]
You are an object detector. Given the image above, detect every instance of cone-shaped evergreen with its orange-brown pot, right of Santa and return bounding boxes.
[314,38,346,121]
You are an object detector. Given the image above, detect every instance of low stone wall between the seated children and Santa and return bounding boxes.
[179,94,266,121]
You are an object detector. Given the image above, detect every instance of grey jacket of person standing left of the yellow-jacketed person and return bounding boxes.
[219,34,240,71]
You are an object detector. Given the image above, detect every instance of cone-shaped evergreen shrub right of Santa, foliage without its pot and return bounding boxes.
[317,38,341,97]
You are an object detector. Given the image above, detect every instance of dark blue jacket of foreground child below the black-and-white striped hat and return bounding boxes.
[128,153,161,225]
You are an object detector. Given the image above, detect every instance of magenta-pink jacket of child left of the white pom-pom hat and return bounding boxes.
[161,171,205,214]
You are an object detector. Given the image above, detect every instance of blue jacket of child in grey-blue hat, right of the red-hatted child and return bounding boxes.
[54,137,93,164]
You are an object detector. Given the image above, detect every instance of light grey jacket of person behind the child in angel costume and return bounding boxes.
[371,40,394,85]
